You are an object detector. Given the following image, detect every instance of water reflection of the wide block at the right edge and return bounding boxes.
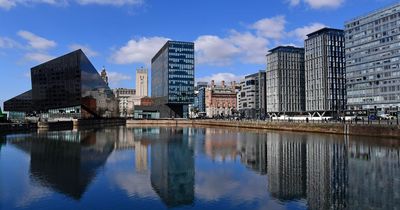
[349,138,400,209]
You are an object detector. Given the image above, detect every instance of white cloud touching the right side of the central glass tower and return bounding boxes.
[195,35,240,65]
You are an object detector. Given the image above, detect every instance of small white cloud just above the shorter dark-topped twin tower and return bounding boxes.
[251,15,286,39]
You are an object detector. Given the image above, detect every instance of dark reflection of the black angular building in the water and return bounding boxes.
[7,130,115,200]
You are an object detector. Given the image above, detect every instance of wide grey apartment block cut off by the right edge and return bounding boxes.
[345,3,400,110]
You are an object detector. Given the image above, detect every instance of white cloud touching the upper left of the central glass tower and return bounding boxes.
[111,37,169,64]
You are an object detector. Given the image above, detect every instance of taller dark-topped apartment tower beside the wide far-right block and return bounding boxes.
[304,28,346,115]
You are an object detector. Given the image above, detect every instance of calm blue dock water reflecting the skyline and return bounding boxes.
[0,127,400,210]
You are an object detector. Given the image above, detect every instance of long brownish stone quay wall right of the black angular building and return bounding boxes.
[126,119,400,139]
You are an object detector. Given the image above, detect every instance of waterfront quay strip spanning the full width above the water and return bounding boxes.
[0,118,400,140]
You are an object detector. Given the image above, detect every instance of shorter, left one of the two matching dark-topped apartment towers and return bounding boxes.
[266,46,305,114]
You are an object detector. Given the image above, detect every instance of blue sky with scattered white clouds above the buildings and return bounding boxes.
[0,0,399,104]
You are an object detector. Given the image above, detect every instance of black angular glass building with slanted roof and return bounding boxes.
[4,50,118,118]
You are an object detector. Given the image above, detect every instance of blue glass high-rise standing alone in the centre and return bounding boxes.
[151,41,195,117]
